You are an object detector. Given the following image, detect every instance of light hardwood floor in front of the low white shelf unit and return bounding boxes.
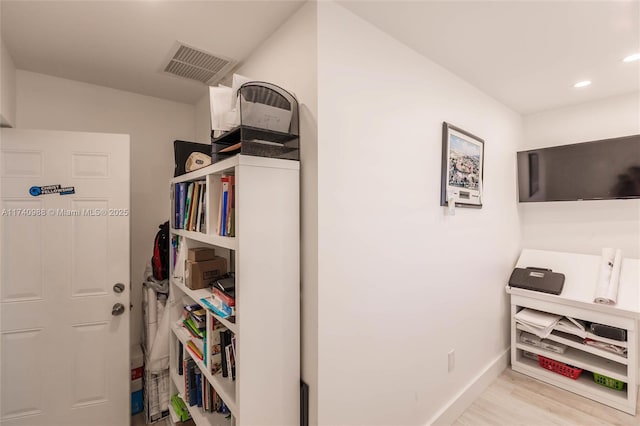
[454,368,640,426]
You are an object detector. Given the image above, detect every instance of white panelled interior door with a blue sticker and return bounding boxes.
[0,129,130,426]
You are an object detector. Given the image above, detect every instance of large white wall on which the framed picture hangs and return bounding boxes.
[318,2,523,425]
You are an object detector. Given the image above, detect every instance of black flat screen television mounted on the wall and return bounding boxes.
[518,135,640,202]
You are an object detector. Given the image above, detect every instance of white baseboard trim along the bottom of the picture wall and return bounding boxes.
[427,348,511,426]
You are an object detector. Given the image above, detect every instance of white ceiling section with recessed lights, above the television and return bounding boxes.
[340,0,640,114]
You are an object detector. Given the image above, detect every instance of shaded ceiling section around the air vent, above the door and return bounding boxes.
[0,0,303,104]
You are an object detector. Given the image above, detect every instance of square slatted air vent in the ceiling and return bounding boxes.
[164,44,236,84]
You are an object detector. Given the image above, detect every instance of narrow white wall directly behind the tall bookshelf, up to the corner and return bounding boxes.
[196,2,318,425]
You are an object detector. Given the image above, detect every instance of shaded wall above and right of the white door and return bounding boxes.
[16,70,195,343]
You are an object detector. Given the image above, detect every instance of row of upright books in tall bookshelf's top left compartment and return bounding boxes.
[173,181,207,232]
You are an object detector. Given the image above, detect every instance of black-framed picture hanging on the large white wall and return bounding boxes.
[440,122,484,208]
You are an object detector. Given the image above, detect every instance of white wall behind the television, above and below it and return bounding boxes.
[519,92,640,258]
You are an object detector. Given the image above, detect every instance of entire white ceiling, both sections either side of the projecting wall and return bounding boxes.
[0,0,640,114]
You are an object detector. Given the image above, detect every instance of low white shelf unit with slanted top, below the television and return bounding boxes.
[507,250,640,415]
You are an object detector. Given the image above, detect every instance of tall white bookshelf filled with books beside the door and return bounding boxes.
[169,155,300,426]
